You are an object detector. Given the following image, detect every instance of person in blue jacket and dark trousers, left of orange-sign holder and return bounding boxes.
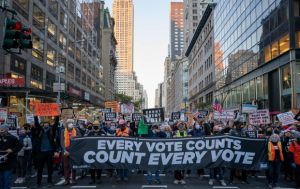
[14,129,32,184]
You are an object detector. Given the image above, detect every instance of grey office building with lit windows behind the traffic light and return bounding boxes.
[0,0,104,124]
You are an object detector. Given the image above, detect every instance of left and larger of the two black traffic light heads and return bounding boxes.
[2,18,22,49]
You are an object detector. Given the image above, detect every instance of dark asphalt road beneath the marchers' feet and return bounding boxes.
[12,170,295,189]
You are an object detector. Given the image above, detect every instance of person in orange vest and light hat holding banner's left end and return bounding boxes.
[60,119,80,185]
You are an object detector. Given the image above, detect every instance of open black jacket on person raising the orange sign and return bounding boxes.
[32,116,59,152]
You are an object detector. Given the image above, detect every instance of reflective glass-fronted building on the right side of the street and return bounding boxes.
[213,0,300,114]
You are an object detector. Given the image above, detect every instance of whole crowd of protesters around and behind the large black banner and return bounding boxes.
[0,114,300,189]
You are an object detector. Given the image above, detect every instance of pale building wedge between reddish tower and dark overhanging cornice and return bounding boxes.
[183,0,213,53]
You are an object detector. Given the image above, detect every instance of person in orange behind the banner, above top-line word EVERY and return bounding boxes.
[116,119,130,182]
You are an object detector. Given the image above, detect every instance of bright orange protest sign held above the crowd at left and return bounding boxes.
[34,103,60,116]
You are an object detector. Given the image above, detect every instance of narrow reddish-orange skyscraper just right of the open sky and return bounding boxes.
[170,2,184,61]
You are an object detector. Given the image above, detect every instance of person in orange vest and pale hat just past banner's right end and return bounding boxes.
[267,134,284,188]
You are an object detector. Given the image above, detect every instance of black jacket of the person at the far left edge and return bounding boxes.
[0,133,23,171]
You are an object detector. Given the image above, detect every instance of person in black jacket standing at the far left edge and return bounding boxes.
[0,124,22,189]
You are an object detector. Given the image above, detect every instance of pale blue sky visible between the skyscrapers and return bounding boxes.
[105,0,171,108]
